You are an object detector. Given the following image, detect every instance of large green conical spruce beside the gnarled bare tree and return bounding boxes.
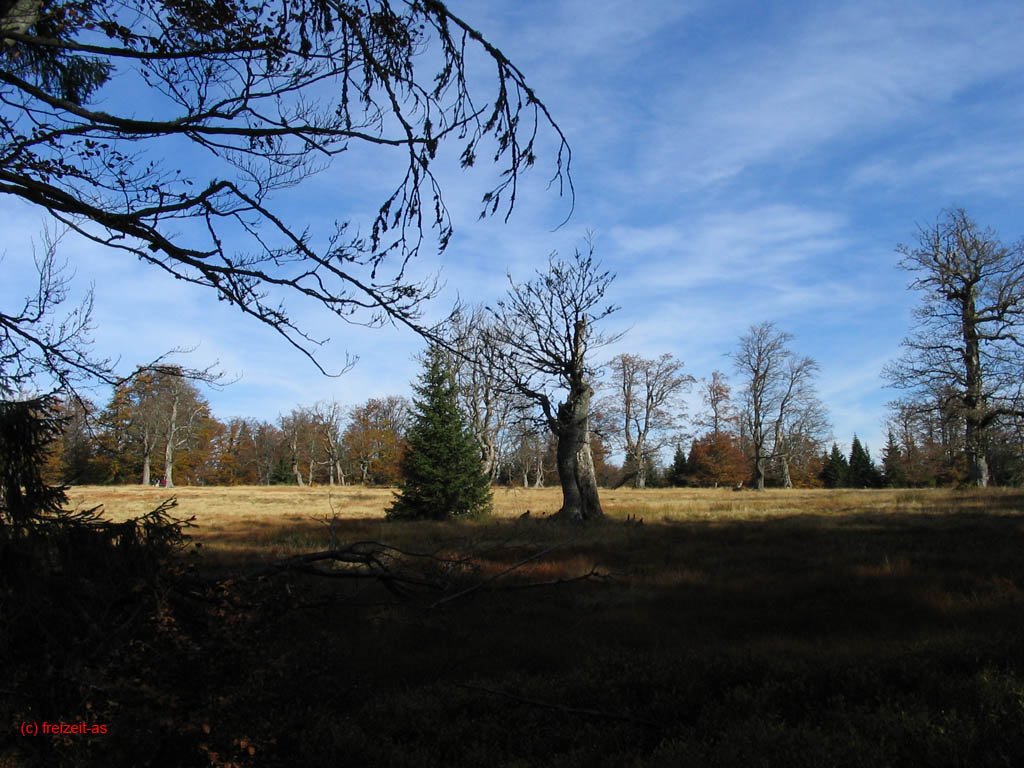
[387,347,490,520]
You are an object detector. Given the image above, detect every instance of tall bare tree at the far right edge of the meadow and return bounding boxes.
[885,209,1024,486]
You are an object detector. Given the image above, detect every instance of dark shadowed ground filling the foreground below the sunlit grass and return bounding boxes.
[0,493,1024,767]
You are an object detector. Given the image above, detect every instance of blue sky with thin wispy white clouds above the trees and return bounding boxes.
[0,0,1024,457]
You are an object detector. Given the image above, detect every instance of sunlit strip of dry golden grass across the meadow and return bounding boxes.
[61,485,1024,554]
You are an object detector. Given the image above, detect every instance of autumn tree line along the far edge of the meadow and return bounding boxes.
[34,312,1024,488]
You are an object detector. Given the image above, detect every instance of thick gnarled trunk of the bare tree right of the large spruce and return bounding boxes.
[555,384,604,522]
